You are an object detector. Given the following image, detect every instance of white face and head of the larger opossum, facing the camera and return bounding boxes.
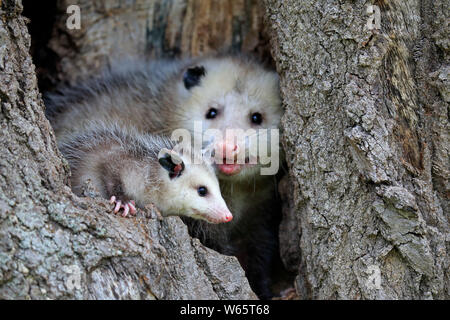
[174,57,282,179]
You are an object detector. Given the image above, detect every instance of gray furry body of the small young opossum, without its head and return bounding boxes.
[58,122,174,205]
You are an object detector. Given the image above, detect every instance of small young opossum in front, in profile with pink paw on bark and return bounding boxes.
[59,124,233,223]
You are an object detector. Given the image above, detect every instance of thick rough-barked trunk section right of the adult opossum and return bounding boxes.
[265,0,450,299]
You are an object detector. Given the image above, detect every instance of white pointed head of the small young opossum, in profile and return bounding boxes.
[158,149,233,223]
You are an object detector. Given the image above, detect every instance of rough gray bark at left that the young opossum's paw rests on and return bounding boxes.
[0,0,255,299]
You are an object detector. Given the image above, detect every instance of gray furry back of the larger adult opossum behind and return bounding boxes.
[44,60,190,141]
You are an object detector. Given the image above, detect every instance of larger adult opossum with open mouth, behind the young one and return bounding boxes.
[46,56,282,298]
